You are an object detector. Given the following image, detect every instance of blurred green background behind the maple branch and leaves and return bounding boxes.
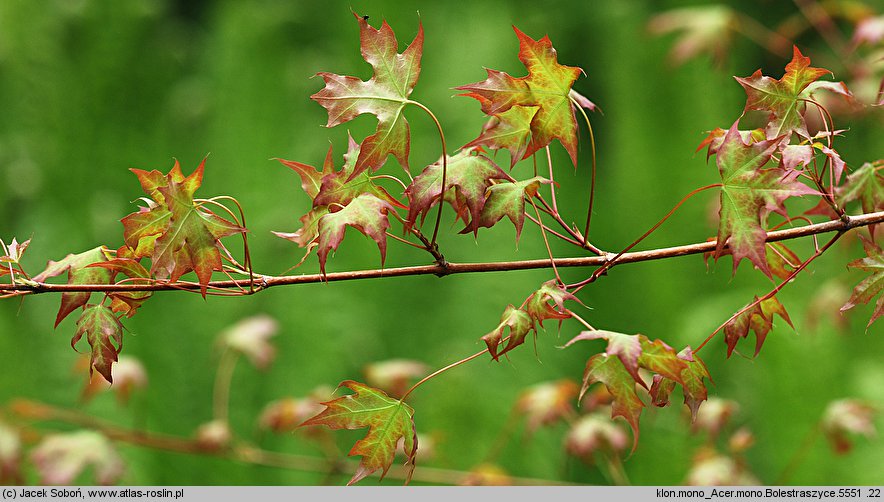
[0,0,884,485]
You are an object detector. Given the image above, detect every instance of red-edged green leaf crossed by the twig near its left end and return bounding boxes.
[34,246,113,326]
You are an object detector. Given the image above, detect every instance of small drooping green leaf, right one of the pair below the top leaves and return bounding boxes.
[461,176,550,242]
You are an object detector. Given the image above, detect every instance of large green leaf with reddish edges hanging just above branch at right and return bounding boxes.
[714,122,818,277]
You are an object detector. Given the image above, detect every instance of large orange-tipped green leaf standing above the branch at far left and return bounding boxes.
[122,159,246,296]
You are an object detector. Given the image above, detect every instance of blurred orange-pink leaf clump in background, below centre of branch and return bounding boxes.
[516,380,580,432]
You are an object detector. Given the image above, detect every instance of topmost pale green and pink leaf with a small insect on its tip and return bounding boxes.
[310,12,424,177]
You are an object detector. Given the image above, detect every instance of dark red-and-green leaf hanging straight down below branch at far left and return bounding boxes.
[71,305,123,383]
